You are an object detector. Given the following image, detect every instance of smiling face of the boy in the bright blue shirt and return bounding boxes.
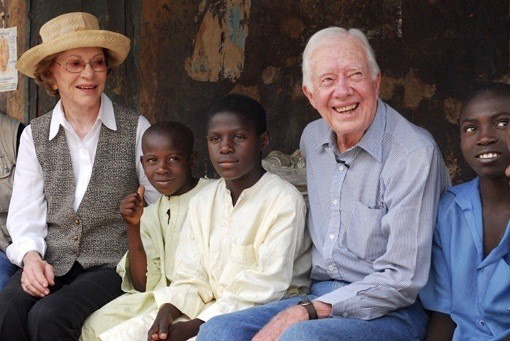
[460,92,510,178]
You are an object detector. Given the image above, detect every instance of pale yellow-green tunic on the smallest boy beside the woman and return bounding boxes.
[81,179,210,340]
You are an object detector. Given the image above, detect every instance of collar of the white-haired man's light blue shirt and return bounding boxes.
[317,99,387,162]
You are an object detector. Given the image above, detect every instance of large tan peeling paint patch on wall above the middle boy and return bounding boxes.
[185,0,251,82]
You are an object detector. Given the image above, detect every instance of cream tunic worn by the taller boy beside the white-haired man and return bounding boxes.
[94,173,311,340]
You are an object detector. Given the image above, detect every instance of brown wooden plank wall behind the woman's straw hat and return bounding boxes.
[0,0,140,123]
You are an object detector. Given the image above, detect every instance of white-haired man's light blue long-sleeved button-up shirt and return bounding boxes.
[301,100,450,320]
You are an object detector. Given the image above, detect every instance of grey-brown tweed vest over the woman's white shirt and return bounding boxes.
[31,105,138,276]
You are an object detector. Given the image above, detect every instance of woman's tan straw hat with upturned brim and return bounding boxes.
[16,12,131,78]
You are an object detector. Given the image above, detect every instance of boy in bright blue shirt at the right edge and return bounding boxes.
[420,83,510,340]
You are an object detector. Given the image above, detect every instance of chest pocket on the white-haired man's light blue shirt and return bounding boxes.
[346,201,387,261]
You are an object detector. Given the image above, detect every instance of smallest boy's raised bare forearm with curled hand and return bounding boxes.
[120,186,147,292]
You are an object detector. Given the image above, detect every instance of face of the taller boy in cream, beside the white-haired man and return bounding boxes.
[207,112,269,185]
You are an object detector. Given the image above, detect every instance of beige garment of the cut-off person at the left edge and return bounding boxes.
[0,114,19,252]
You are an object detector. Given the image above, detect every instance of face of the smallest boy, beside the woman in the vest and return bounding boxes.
[141,133,195,195]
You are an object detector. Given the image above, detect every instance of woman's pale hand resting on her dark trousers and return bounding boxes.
[21,251,55,297]
